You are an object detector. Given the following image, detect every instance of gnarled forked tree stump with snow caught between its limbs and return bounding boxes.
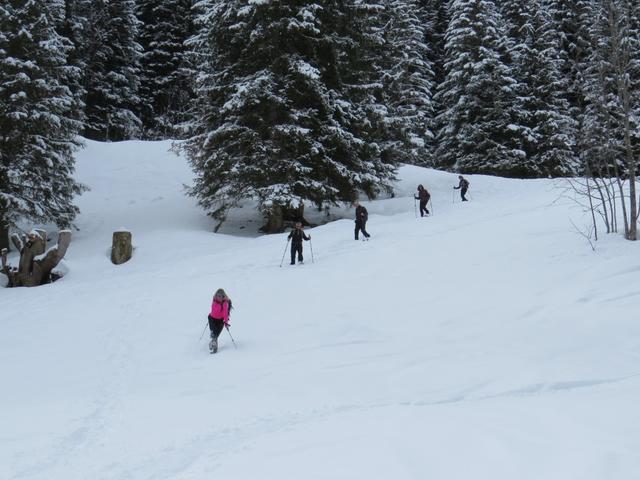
[2,230,71,287]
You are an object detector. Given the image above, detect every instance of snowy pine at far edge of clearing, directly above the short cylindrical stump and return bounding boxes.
[84,0,141,141]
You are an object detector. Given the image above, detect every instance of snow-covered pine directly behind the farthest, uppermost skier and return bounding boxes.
[436,0,536,177]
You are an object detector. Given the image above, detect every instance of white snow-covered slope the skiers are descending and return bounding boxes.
[0,142,640,480]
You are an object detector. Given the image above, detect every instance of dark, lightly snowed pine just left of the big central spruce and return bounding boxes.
[137,0,193,139]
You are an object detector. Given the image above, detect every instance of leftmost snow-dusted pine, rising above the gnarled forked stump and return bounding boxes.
[0,0,83,236]
